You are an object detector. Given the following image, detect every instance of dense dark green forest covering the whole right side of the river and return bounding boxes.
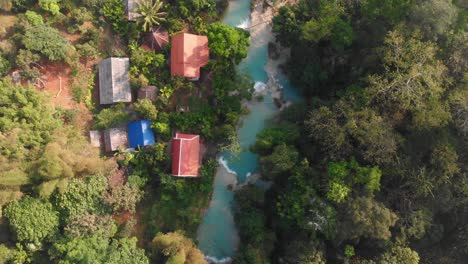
[266,0,468,264]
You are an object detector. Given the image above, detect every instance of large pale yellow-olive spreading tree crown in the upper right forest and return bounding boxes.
[369,31,448,127]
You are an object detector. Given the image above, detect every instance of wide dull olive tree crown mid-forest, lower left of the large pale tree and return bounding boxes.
[306,104,398,164]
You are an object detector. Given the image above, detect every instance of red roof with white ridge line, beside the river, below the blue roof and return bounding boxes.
[172,133,200,177]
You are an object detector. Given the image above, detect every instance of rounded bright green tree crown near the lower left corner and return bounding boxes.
[4,196,59,245]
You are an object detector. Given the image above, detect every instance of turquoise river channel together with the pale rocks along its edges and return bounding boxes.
[197,0,298,263]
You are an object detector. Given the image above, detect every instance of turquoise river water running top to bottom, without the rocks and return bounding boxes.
[197,0,299,263]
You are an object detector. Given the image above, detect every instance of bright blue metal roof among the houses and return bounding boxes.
[127,120,154,148]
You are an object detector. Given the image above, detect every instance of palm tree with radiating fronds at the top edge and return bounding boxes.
[135,0,167,31]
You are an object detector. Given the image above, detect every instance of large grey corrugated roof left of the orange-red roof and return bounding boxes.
[99,58,132,104]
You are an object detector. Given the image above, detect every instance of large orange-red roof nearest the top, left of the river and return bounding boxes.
[171,33,210,79]
